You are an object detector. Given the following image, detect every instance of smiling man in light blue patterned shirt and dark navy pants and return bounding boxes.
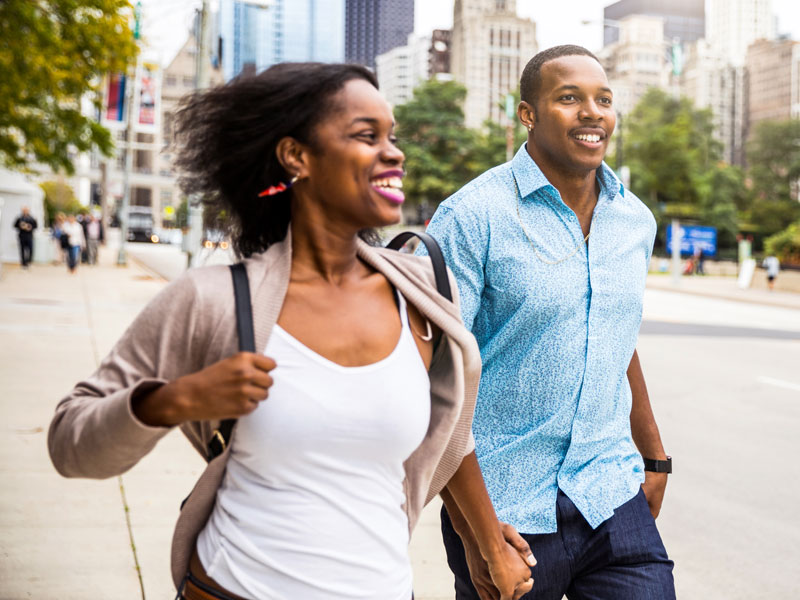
[428,46,675,600]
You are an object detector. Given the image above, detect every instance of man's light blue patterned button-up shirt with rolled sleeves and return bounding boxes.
[428,144,656,533]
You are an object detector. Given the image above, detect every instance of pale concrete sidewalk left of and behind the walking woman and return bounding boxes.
[0,248,452,600]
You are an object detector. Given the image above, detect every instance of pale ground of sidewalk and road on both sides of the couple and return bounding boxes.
[0,244,800,600]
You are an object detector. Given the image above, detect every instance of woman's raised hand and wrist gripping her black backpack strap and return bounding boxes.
[132,352,275,427]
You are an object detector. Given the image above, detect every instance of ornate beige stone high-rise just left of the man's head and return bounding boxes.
[450,0,538,127]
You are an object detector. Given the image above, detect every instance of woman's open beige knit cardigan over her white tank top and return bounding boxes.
[48,235,481,586]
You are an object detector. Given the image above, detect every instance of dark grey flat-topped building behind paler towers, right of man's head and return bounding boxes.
[603,0,705,45]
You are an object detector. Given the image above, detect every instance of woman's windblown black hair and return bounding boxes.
[175,63,378,256]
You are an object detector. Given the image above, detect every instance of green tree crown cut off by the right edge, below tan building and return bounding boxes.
[747,119,800,236]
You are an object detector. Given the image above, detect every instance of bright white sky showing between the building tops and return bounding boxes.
[142,0,800,62]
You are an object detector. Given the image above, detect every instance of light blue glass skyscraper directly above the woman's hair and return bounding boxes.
[217,0,345,80]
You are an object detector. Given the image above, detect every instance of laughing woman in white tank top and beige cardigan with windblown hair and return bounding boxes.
[49,63,534,600]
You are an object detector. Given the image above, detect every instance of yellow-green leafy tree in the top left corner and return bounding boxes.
[0,0,137,174]
